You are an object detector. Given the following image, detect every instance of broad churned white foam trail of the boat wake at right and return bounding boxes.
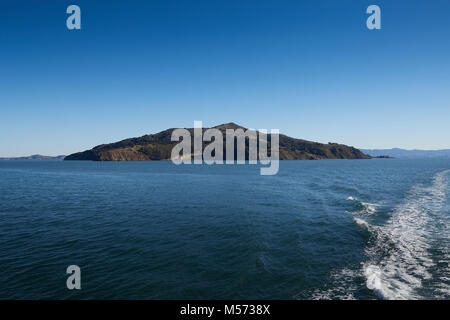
[364,170,450,299]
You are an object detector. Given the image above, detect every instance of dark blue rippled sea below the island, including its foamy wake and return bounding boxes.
[0,159,450,299]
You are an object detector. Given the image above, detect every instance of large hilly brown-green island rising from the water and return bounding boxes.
[64,123,371,161]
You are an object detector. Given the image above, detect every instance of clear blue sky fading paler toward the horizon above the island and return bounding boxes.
[0,0,450,156]
